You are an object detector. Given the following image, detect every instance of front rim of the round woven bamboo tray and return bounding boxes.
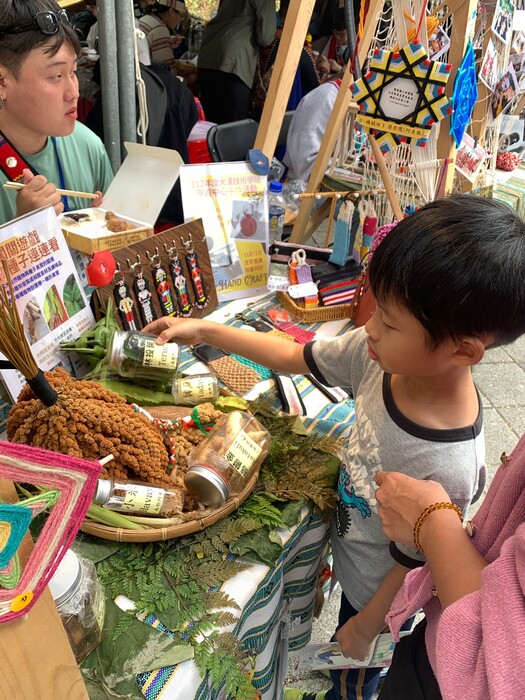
[80,474,258,542]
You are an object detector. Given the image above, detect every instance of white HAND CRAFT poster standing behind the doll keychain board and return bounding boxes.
[180,162,268,301]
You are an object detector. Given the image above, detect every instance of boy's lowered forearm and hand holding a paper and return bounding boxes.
[335,564,409,661]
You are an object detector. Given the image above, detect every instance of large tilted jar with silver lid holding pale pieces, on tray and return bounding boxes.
[184,411,271,508]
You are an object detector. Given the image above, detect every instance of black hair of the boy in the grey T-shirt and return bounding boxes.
[369,195,525,347]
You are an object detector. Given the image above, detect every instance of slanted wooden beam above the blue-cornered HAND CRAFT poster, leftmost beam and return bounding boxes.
[254,0,315,161]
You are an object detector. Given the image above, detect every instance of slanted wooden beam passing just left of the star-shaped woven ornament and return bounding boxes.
[290,0,383,243]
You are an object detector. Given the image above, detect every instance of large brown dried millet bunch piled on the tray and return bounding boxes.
[7,368,173,488]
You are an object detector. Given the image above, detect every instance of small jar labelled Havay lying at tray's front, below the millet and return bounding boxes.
[93,479,182,515]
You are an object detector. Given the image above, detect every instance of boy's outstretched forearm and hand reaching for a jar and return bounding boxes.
[144,317,310,374]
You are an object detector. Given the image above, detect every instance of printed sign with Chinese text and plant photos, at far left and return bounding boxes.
[0,207,95,400]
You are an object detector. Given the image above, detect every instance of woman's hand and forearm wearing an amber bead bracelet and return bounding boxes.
[375,472,487,607]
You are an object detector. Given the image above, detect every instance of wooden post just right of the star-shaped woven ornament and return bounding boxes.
[435,0,478,199]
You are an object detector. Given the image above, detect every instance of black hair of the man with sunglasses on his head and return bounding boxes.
[0,0,80,77]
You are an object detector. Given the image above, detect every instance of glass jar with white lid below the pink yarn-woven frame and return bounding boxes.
[49,549,105,663]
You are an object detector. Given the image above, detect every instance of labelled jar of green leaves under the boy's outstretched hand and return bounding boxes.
[106,331,180,381]
